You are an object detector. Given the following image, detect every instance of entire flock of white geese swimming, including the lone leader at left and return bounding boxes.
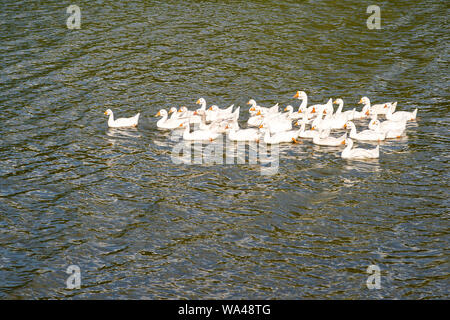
[105,91,417,159]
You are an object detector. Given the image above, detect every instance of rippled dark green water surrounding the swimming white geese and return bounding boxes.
[0,1,450,299]
